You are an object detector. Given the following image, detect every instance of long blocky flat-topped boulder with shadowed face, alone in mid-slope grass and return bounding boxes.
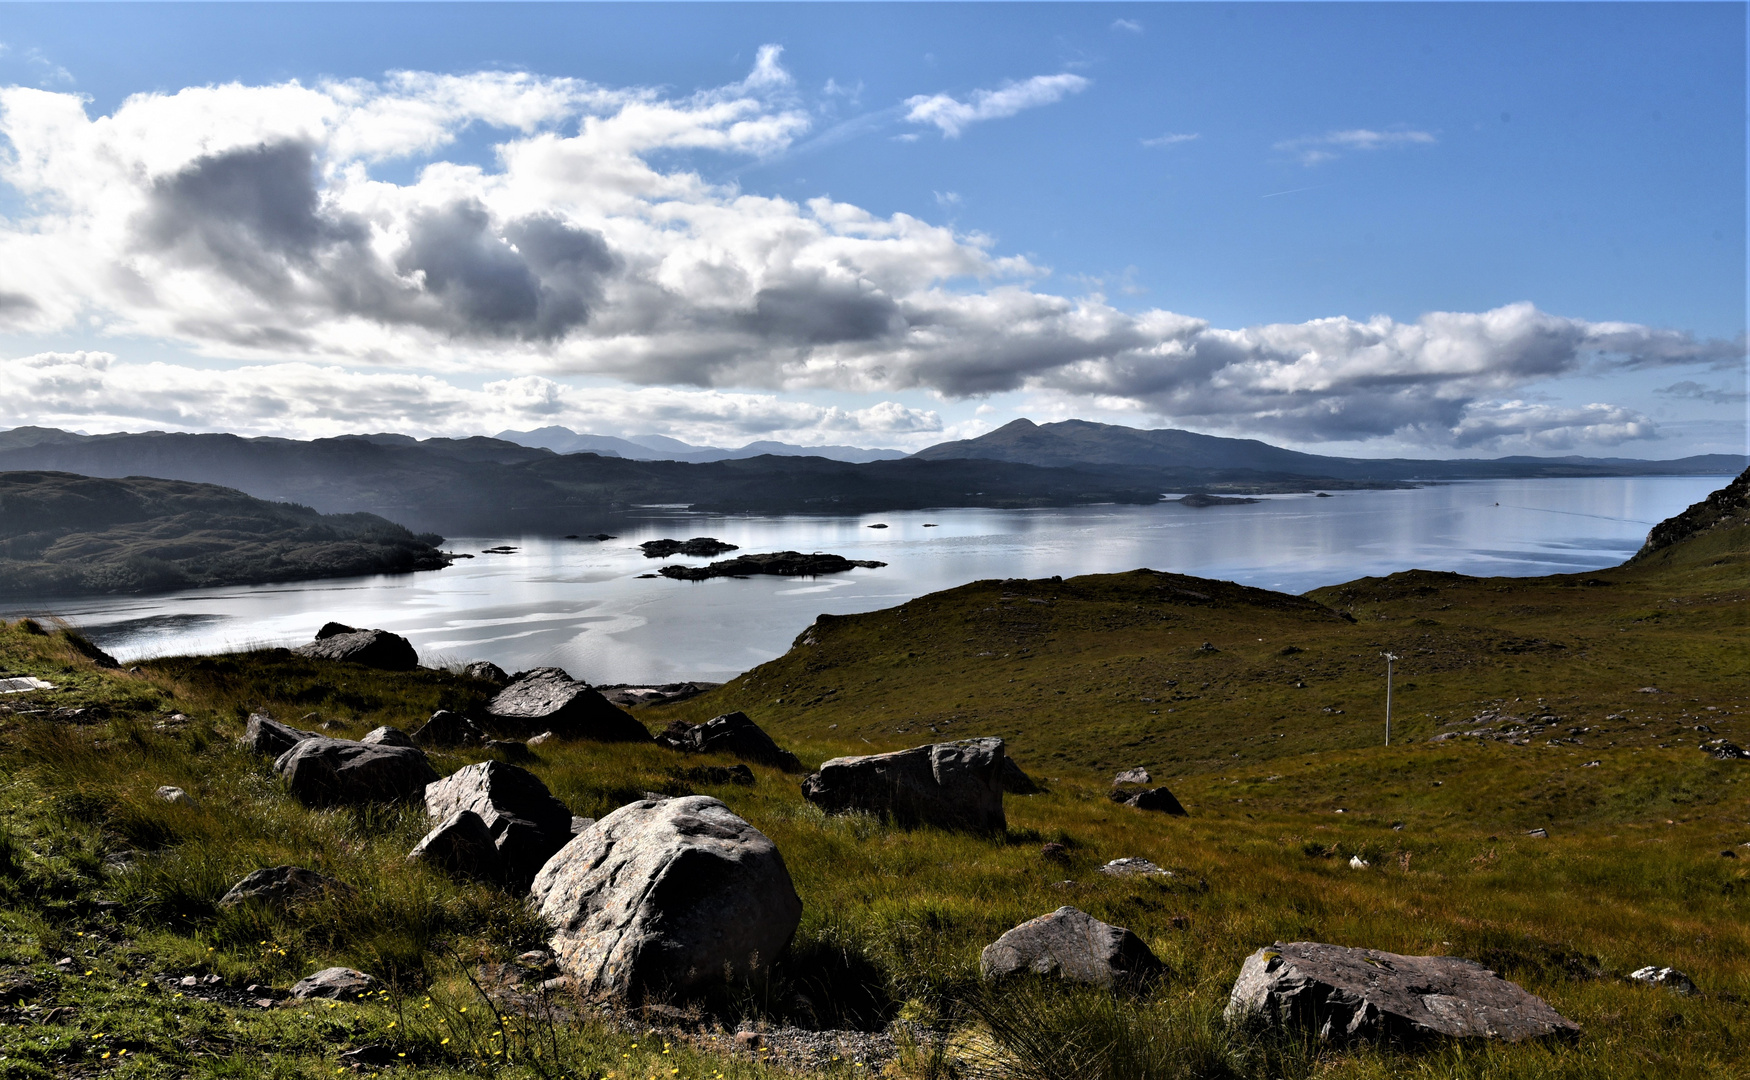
[802,739,1008,831]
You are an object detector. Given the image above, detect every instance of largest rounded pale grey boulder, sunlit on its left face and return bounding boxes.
[530,795,802,999]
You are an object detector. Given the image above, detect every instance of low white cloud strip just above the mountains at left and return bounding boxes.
[0,352,943,445]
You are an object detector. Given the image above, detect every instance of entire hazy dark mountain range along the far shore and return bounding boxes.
[0,420,1747,536]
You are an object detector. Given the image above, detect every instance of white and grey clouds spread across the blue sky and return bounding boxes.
[0,46,1743,450]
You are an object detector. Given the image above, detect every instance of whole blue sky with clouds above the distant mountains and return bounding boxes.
[0,4,1747,459]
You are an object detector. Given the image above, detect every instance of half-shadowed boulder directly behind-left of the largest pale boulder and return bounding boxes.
[425,761,571,889]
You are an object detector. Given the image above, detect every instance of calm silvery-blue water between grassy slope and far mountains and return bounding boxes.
[7,476,1729,683]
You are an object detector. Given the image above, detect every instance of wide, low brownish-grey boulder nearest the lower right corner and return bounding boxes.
[1227,942,1580,1043]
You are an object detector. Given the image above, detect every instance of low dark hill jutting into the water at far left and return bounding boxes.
[0,473,450,597]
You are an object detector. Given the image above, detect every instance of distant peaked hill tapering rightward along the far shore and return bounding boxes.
[914,418,1750,481]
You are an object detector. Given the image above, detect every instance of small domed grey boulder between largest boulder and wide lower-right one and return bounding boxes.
[978,907,1162,985]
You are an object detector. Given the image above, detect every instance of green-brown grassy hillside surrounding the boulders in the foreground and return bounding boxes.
[0,472,1750,1080]
